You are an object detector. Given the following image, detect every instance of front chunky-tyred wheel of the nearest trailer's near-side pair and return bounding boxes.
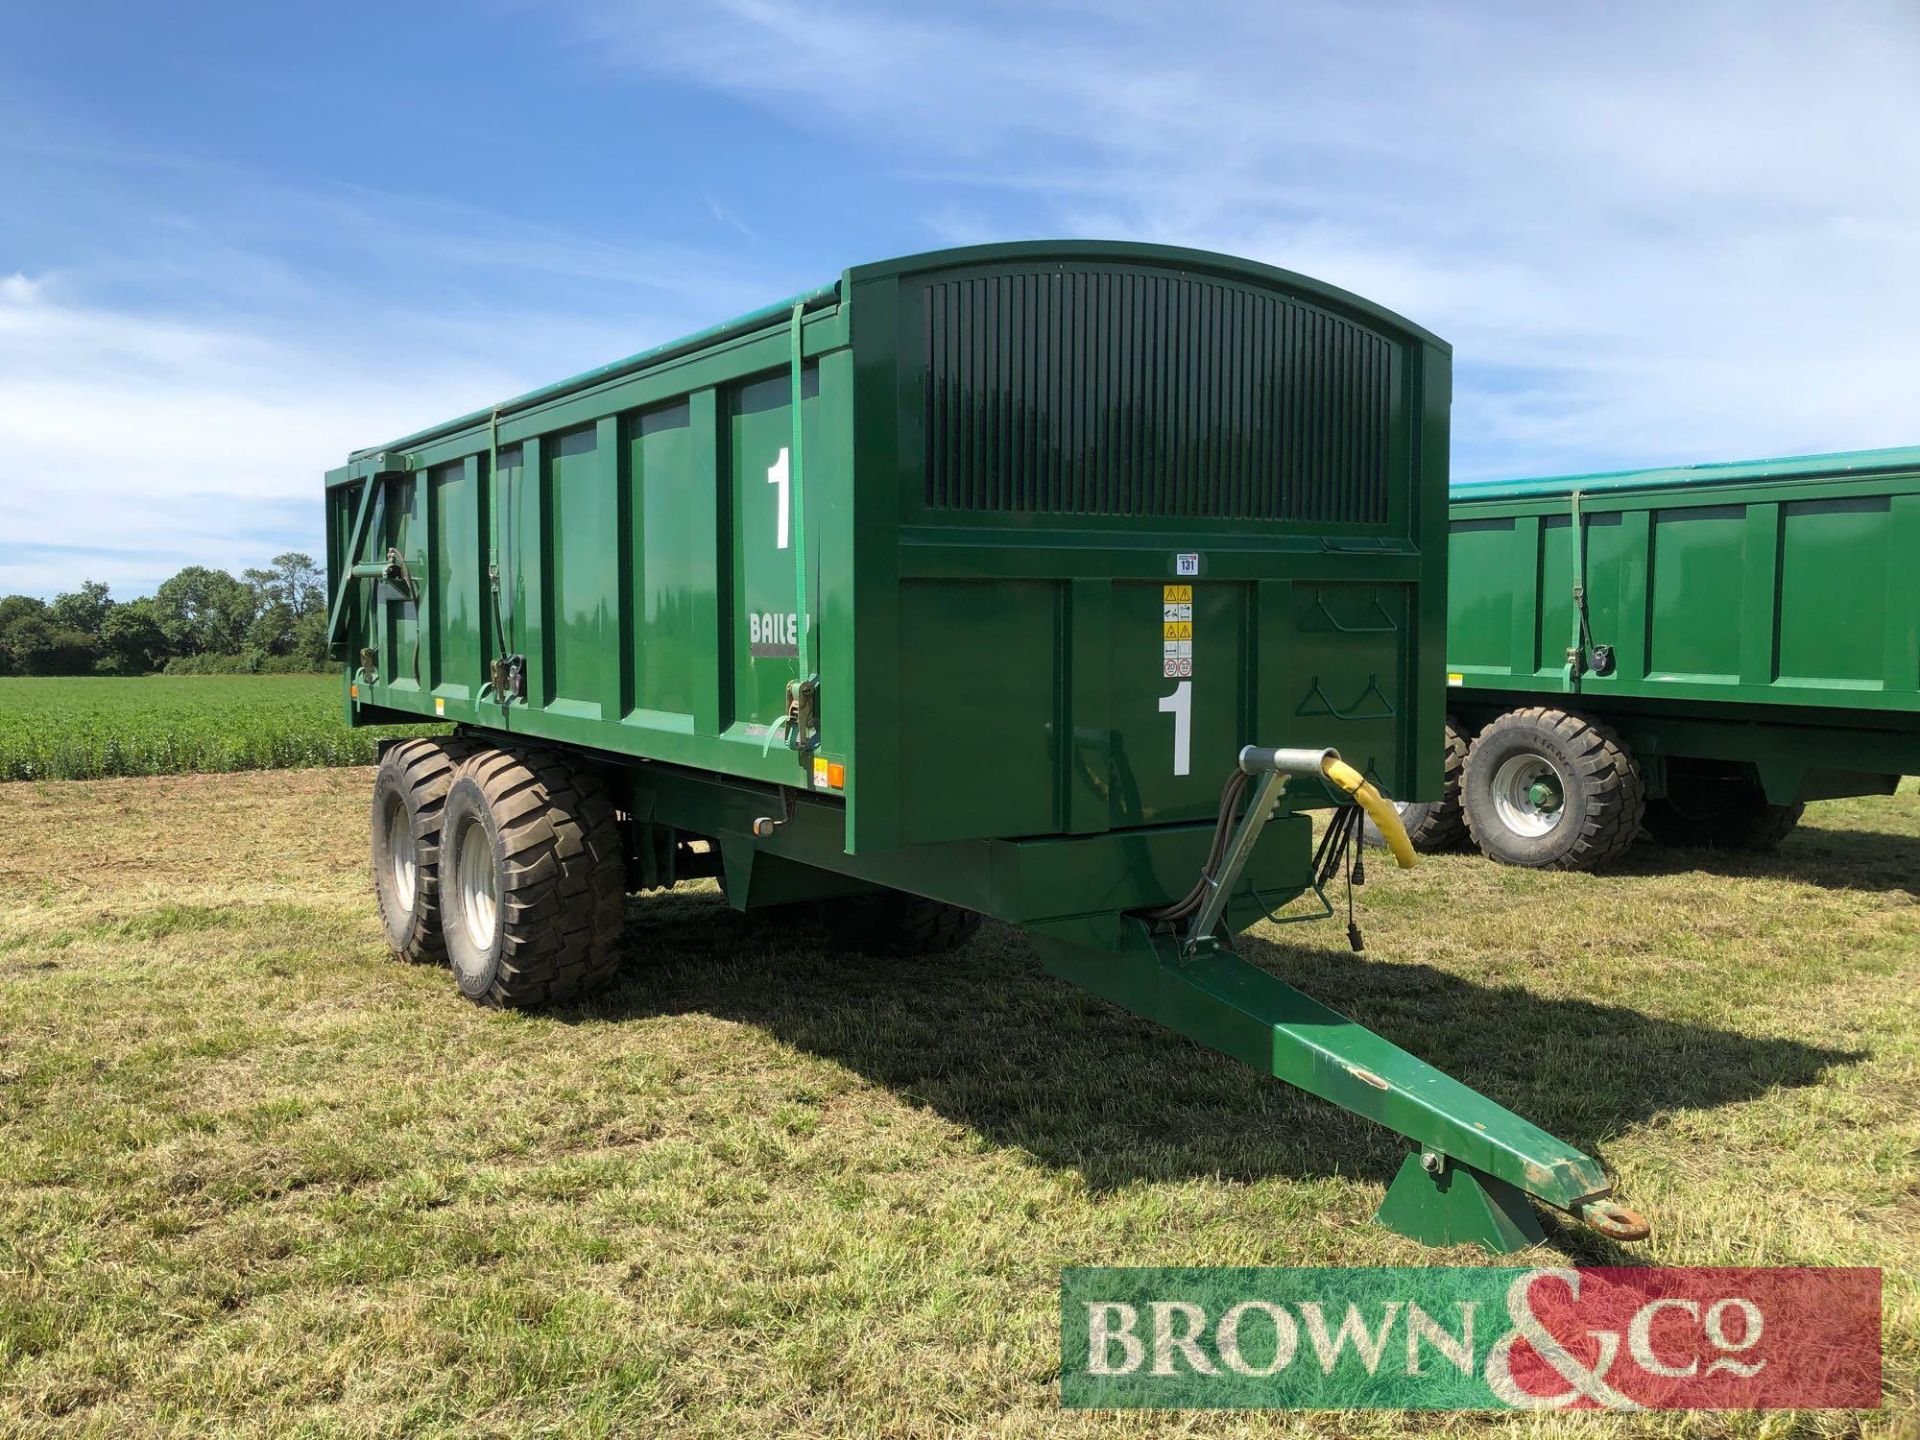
[440,749,626,1008]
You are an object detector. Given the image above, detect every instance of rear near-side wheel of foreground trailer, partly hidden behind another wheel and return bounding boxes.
[371,739,470,964]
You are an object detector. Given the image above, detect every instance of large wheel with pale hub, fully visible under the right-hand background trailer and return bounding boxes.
[1461,707,1647,870]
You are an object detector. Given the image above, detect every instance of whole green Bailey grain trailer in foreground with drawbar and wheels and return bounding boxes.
[326,244,1644,1248]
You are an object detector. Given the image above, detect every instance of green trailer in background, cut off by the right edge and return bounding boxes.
[1404,449,1920,868]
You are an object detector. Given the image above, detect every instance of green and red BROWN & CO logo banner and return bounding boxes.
[1060,1265,1882,1409]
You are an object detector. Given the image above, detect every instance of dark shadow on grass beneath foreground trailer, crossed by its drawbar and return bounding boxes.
[576,897,1864,1213]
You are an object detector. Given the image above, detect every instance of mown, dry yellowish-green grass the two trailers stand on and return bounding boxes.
[0,771,1920,1440]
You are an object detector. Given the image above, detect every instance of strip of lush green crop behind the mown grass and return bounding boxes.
[0,676,437,780]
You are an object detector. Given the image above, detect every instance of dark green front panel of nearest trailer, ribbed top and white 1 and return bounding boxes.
[856,257,1444,841]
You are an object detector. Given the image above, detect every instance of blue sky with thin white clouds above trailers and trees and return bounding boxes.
[0,0,1920,597]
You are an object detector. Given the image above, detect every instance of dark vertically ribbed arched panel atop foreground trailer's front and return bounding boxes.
[920,267,1394,526]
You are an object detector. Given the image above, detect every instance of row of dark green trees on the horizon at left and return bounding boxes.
[0,551,326,676]
